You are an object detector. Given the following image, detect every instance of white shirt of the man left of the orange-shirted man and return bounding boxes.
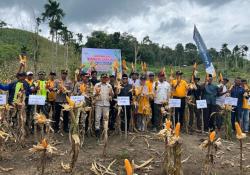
[153,81,171,104]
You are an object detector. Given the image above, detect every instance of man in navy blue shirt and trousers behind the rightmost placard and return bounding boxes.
[229,77,245,130]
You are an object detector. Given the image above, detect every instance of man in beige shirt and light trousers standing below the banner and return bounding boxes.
[94,73,114,140]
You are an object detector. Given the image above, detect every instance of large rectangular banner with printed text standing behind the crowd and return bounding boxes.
[82,48,121,74]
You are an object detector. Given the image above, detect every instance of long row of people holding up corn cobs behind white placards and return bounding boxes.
[0,63,250,140]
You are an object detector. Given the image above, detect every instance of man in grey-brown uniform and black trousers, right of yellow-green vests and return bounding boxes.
[53,70,73,133]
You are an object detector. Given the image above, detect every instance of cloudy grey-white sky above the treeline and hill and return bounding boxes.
[0,0,250,50]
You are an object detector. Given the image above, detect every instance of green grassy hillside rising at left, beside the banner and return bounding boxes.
[0,28,80,78]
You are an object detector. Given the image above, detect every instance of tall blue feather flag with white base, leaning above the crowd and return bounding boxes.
[193,26,216,77]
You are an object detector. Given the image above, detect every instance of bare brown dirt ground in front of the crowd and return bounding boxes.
[0,133,250,175]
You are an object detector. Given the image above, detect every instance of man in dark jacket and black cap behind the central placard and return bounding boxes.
[117,74,132,131]
